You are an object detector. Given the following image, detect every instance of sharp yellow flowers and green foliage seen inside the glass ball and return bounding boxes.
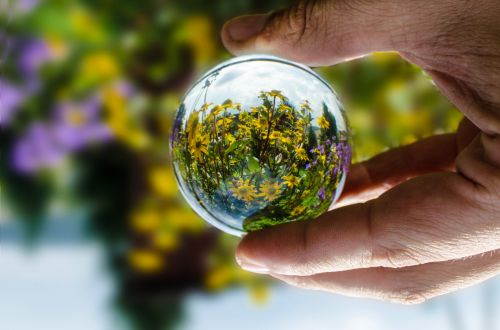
[172,90,350,231]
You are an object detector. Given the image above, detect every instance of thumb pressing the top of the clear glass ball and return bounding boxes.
[221,0,448,66]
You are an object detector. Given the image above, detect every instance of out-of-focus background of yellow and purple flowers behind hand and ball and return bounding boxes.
[0,0,500,330]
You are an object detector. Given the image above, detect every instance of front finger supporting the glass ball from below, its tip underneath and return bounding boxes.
[237,169,500,275]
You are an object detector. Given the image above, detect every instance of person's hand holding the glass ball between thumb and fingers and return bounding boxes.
[222,0,500,303]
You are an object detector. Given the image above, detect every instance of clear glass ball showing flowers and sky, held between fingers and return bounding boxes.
[170,55,351,236]
